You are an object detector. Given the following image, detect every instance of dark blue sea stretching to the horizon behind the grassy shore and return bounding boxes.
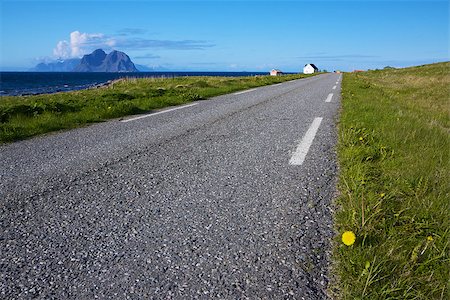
[0,72,268,96]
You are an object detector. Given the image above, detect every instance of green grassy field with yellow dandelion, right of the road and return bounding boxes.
[330,62,450,299]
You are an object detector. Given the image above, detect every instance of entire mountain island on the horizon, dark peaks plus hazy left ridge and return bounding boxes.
[30,49,139,72]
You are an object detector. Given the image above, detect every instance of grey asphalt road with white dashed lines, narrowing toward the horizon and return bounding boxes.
[0,74,340,299]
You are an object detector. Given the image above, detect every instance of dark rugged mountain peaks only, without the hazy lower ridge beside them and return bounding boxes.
[73,49,139,72]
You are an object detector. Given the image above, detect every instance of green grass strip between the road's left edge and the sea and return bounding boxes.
[0,74,311,143]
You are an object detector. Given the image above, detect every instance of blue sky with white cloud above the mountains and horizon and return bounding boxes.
[0,0,449,72]
